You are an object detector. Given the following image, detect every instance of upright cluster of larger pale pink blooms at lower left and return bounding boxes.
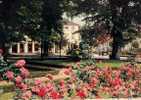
[5,60,32,100]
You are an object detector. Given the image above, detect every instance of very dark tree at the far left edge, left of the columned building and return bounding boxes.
[0,0,20,58]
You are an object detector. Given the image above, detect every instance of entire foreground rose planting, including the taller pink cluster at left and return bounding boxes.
[0,49,141,100]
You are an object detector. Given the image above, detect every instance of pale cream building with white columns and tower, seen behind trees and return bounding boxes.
[9,20,81,55]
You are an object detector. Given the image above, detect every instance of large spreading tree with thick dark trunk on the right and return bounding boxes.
[69,0,141,59]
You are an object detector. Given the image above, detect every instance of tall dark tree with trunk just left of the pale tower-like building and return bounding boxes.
[41,0,63,56]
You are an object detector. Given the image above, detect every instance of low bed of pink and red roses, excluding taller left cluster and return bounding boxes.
[29,64,141,99]
